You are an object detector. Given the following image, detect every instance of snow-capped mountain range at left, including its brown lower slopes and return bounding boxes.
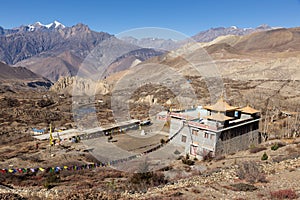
[0,21,161,82]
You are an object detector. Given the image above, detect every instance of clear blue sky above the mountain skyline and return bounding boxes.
[0,0,300,36]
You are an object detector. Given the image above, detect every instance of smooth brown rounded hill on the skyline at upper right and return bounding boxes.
[201,28,300,54]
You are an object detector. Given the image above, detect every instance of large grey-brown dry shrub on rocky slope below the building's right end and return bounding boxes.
[236,161,267,183]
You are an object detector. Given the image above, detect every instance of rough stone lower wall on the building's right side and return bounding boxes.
[216,130,261,155]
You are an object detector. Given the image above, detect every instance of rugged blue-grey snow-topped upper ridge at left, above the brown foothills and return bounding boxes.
[0,23,112,64]
